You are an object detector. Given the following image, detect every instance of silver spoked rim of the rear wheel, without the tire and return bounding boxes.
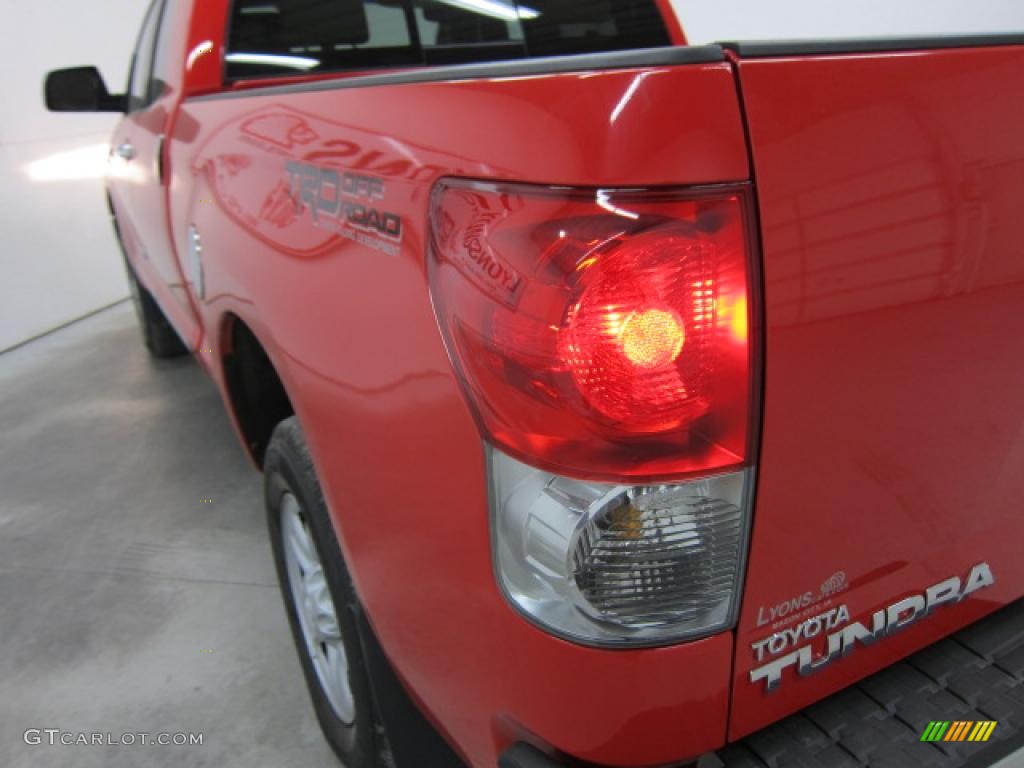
[281,493,355,725]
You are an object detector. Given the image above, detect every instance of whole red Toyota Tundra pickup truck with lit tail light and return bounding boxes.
[45,0,1024,768]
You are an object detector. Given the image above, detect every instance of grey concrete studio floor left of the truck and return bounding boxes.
[0,303,338,768]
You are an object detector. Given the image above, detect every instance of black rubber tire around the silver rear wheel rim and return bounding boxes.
[263,417,391,768]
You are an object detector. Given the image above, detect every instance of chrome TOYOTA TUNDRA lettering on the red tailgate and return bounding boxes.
[751,562,994,692]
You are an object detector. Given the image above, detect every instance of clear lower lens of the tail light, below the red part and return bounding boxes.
[489,451,752,646]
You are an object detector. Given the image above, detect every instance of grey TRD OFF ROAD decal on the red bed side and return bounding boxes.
[285,160,401,256]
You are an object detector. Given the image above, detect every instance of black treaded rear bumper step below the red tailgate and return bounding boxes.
[499,600,1024,768]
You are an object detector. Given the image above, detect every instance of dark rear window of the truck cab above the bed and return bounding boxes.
[225,0,670,80]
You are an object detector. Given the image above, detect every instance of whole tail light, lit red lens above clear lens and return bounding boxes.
[430,180,753,642]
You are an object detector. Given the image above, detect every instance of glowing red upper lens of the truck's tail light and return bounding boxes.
[430,180,752,480]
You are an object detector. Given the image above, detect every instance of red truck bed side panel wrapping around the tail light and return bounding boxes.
[165,62,749,766]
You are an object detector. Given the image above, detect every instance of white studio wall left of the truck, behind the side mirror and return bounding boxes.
[0,0,145,350]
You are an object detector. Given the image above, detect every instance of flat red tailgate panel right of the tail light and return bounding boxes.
[730,46,1024,738]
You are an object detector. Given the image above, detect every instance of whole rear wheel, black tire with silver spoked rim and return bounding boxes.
[264,417,389,768]
